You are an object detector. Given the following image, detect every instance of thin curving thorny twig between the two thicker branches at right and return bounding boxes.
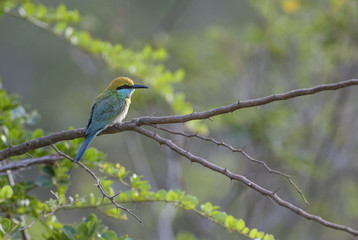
[151,125,310,205]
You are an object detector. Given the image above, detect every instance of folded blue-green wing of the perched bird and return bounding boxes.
[84,96,125,137]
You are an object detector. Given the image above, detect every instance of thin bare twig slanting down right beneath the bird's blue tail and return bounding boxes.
[51,144,142,223]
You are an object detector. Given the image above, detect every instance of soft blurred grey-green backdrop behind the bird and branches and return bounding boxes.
[0,0,358,240]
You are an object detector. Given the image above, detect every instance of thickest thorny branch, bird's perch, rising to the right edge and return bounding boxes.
[0,79,358,160]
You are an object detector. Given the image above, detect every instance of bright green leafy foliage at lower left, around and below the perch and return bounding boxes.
[0,82,274,240]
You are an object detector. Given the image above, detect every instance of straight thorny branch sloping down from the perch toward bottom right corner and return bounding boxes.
[133,126,358,236]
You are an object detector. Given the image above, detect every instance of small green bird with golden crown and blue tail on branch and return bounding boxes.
[67,77,148,177]
